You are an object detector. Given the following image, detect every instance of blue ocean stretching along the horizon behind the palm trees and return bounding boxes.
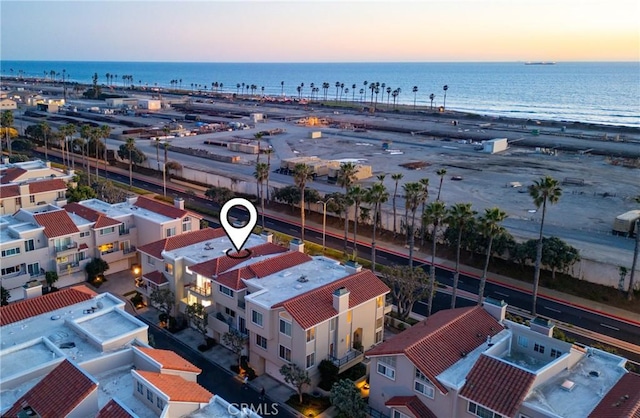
[0,61,640,127]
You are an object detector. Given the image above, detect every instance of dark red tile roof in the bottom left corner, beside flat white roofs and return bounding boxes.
[3,360,98,417]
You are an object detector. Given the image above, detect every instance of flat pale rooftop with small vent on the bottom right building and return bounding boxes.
[523,348,626,418]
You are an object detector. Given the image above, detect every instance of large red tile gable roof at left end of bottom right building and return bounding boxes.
[367,306,503,393]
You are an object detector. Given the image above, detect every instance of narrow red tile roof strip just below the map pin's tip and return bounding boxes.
[215,251,311,290]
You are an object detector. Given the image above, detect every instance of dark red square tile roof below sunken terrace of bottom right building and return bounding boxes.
[460,354,536,417]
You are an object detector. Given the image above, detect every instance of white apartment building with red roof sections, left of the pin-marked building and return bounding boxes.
[0,194,201,301]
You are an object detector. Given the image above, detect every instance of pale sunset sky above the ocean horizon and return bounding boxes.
[0,0,640,62]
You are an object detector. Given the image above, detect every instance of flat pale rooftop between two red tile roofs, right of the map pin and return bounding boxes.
[245,256,344,308]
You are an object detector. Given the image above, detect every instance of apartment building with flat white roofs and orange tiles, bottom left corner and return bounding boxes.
[0,286,258,418]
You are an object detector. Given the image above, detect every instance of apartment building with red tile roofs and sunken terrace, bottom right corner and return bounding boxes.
[367,299,640,418]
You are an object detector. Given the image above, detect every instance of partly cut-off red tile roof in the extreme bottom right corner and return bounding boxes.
[589,373,640,418]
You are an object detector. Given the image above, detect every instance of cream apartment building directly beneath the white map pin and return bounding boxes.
[138,229,390,382]
